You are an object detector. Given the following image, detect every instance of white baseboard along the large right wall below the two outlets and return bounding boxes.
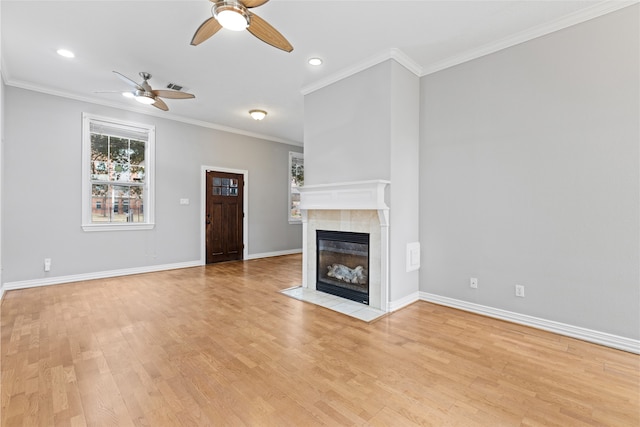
[420,292,640,354]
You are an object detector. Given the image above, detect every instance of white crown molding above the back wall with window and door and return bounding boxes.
[2,78,304,147]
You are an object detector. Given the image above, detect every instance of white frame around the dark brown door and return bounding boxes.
[200,165,249,265]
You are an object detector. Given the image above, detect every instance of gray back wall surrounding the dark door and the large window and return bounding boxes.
[2,87,302,283]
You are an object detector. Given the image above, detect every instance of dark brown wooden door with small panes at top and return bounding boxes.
[206,171,244,264]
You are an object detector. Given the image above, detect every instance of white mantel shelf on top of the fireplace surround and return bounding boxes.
[299,180,390,211]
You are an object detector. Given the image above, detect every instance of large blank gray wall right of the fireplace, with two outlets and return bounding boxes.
[420,5,640,339]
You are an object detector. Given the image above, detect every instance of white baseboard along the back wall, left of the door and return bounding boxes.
[2,261,201,291]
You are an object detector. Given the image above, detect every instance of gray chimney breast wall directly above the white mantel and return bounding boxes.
[304,61,391,185]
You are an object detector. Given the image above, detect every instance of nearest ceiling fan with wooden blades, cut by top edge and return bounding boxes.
[191,0,293,52]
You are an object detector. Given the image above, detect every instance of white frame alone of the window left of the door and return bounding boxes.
[82,113,156,231]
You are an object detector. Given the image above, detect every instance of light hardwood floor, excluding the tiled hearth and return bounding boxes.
[1,255,640,427]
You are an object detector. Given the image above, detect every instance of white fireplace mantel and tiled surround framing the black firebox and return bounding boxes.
[300,180,389,312]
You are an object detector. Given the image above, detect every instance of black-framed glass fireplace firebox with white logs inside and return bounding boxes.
[316,230,369,305]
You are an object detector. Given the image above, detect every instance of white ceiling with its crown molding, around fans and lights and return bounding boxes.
[0,0,633,145]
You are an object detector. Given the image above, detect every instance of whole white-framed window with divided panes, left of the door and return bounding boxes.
[82,114,155,231]
